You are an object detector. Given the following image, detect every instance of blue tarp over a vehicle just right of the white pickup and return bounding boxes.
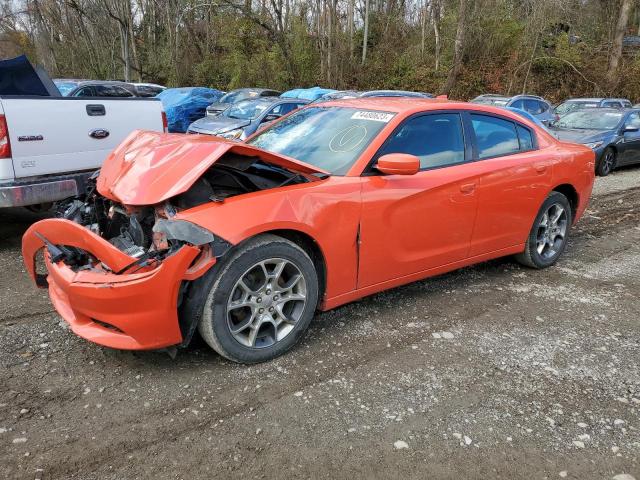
[156,87,224,133]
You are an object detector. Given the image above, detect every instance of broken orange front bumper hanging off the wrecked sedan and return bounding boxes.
[22,219,208,350]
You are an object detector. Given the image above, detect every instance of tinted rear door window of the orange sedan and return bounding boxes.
[471,114,520,159]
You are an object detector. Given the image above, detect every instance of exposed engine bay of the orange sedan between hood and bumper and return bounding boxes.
[56,153,310,273]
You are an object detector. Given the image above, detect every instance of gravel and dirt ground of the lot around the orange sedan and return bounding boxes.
[0,168,640,480]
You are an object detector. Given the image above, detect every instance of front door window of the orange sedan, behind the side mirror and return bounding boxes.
[381,113,464,170]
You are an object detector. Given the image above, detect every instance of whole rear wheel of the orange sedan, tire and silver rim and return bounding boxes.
[516,192,573,268]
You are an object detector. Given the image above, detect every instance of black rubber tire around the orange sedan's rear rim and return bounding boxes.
[515,191,573,269]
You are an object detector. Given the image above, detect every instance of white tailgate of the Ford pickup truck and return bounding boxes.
[0,97,163,179]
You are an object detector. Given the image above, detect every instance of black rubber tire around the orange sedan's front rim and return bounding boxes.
[198,234,319,364]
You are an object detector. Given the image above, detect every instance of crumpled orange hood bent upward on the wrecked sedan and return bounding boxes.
[97,130,328,206]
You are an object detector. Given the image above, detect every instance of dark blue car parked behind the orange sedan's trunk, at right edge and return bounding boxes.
[549,108,640,176]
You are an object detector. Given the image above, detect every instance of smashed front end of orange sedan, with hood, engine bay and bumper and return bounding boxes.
[22,132,328,350]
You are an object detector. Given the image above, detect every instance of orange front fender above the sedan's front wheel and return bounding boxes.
[175,177,361,299]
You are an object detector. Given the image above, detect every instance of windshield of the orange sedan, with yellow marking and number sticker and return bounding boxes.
[248,106,395,175]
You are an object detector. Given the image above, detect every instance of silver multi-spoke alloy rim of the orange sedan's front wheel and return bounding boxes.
[227,258,307,348]
